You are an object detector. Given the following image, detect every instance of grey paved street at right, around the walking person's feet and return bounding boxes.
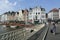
[45,24,60,40]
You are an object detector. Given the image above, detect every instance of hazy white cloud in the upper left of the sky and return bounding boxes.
[0,0,17,14]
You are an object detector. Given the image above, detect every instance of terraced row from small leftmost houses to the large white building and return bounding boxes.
[0,6,46,24]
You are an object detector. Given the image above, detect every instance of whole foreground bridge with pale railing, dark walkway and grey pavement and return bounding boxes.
[0,24,60,40]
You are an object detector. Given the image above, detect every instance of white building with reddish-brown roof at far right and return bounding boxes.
[48,8,60,20]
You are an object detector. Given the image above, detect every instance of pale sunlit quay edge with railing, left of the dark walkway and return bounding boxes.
[0,24,44,40]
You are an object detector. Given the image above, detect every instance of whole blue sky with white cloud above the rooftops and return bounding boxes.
[0,0,60,14]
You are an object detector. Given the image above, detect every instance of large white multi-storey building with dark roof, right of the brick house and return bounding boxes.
[28,7,46,23]
